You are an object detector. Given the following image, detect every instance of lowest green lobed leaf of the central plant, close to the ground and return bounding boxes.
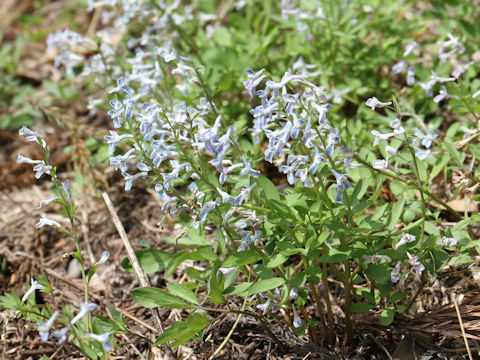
[155,314,210,347]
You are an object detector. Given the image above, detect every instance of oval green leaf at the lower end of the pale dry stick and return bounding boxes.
[130,287,193,309]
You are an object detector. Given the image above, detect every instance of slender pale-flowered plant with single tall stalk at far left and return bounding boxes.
[0,126,124,359]
